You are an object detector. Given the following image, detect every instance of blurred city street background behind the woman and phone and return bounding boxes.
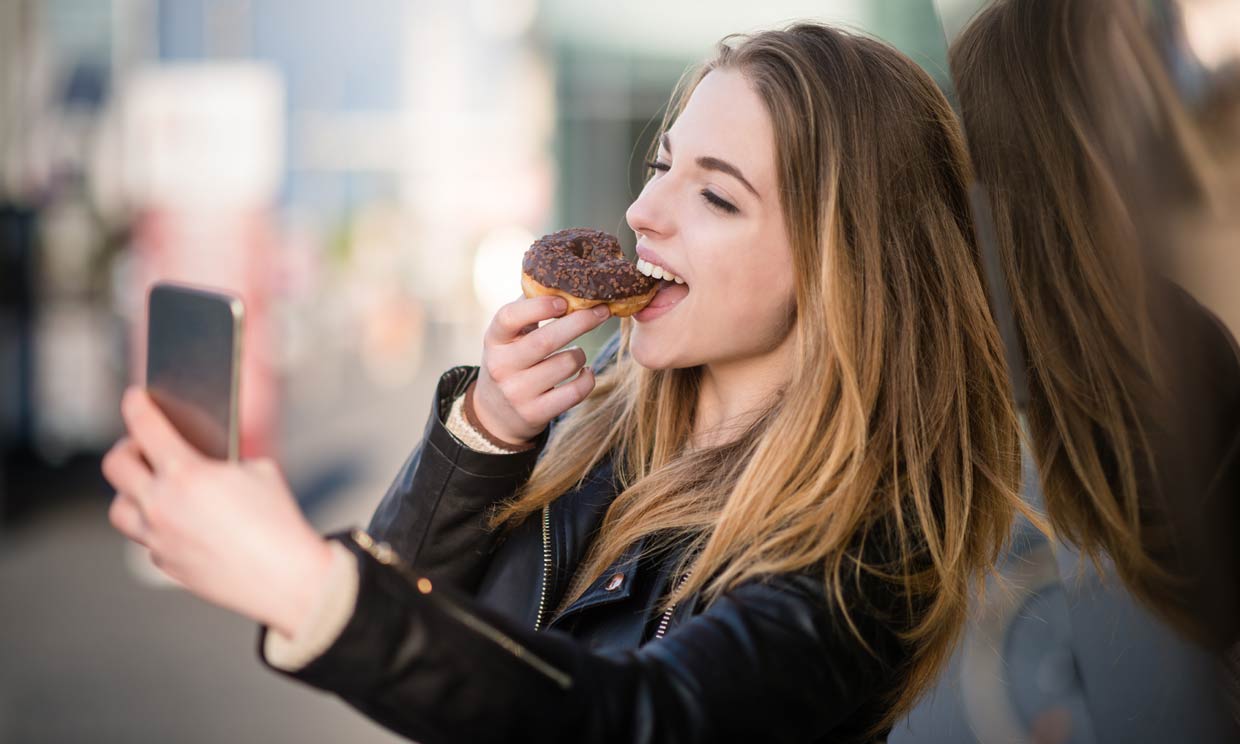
[0,0,946,743]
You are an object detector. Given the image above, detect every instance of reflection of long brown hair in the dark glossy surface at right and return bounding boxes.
[950,0,1203,629]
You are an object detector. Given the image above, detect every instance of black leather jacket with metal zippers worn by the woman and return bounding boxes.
[259,339,905,744]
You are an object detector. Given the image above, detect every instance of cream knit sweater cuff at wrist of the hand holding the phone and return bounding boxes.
[263,541,358,672]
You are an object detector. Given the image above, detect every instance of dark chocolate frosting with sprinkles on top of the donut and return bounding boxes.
[521,227,658,300]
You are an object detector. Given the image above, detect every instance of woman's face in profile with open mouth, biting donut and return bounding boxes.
[626,69,794,370]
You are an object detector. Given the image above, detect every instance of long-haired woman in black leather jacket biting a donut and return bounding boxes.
[104,24,1019,742]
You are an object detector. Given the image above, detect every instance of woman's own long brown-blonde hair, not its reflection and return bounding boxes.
[494,24,1019,722]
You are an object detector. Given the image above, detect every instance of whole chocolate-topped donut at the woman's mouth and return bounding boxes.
[521,227,658,317]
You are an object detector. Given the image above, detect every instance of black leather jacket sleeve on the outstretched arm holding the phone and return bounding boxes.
[259,532,900,744]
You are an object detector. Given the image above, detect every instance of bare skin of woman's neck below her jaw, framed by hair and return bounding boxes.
[689,334,795,449]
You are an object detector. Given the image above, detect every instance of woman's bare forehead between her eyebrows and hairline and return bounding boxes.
[668,69,775,193]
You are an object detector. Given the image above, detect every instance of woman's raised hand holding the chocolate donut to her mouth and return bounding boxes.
[474,296,610,444]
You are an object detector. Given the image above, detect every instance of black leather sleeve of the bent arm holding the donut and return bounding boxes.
[368,367,547,593]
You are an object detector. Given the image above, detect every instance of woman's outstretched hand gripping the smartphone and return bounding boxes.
[103,388,331,636]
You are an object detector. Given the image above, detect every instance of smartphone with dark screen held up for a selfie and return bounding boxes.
[146,281,246,460]
